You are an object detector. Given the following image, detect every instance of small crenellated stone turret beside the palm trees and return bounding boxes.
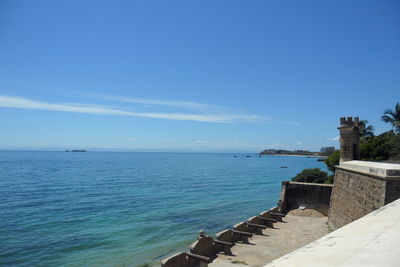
[338,117,360,162]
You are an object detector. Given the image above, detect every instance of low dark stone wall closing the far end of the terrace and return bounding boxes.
[281,182,332,216]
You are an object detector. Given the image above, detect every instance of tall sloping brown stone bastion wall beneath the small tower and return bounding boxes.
[328,161,400,230]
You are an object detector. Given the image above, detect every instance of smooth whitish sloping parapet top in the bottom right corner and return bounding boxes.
[266,199,400,267]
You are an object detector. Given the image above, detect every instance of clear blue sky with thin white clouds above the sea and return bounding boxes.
[0,0,400,152]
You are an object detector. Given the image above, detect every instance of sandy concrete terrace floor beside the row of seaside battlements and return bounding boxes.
[209,210,328,267]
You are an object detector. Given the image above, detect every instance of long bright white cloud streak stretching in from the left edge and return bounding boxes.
[0,95,263,123]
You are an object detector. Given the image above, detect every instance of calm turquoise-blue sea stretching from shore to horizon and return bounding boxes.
[0,151,326,266]
